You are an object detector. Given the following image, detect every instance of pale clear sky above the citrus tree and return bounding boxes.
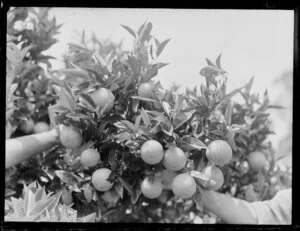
[47,8,294,168]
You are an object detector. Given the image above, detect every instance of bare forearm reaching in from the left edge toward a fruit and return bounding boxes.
[5,129,57,168]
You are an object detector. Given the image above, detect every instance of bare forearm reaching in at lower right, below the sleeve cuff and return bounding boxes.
[201,190,258,224]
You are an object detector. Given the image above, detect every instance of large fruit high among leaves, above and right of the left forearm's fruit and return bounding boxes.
[92,87,115,113]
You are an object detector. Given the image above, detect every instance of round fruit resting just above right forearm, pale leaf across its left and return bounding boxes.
[202,165,224,190]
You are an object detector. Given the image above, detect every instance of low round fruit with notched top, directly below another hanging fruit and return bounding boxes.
[141,177,162,199]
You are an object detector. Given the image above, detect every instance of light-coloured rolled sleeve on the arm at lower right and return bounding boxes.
[251,188,292,225]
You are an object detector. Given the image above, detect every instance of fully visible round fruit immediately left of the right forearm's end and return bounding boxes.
[172,173,197,198]
